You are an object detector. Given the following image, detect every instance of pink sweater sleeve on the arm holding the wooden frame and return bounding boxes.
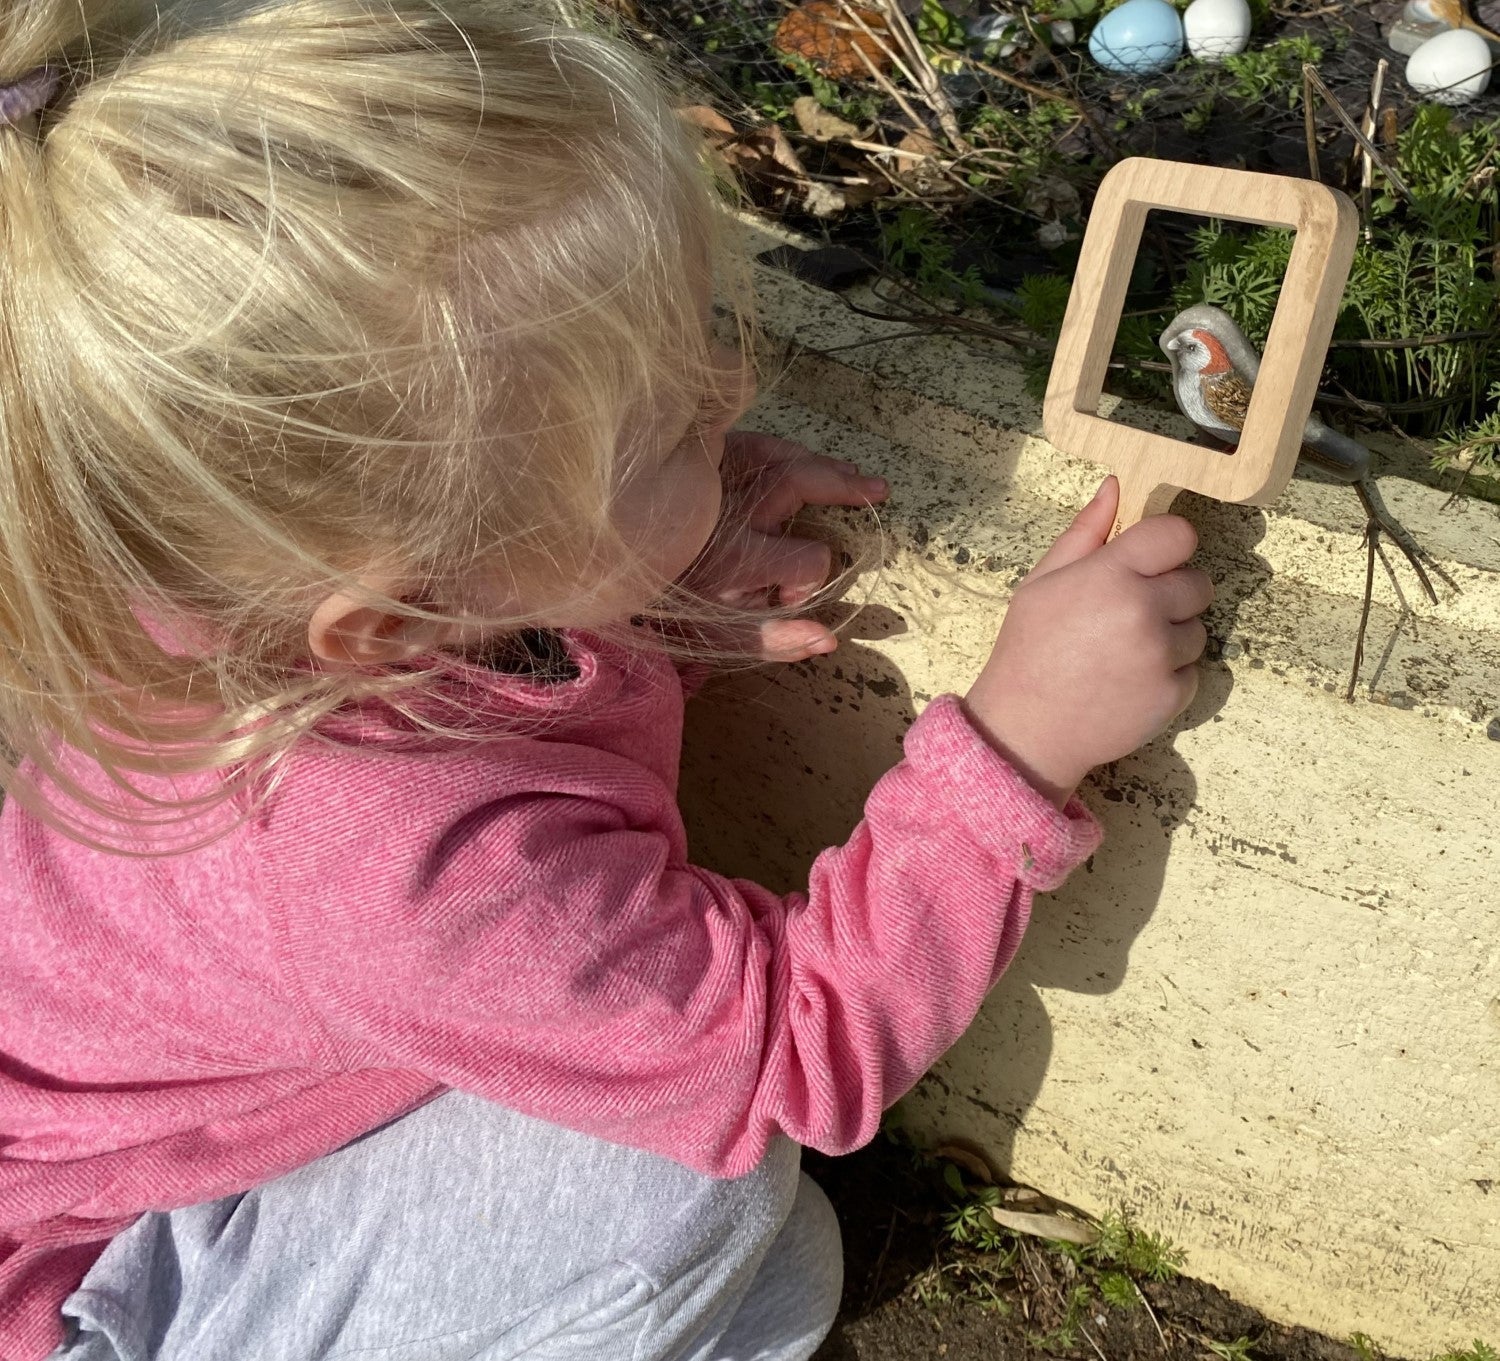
[266,698,1100,1176]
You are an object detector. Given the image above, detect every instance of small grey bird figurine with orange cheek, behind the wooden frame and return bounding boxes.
[1160,303,1442,605]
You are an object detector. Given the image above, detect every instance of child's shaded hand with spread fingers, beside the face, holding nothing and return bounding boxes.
[684,432,888,662]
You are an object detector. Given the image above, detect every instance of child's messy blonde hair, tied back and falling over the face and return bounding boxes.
[0,0,750,828]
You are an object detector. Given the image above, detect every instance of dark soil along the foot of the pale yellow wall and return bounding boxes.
[803,1137,1386,1361]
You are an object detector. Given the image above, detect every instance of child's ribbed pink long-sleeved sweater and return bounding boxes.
[0,638,1100,1361]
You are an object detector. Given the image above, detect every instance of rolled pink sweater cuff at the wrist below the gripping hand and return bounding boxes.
[905,695,1104,893]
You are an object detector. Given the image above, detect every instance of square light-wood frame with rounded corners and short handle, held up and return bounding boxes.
[1043,158,1359,537]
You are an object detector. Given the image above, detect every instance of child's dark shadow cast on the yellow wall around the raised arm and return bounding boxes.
[681,495,1271,1307]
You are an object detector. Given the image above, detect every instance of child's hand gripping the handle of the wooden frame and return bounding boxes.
[966,477,1214,807]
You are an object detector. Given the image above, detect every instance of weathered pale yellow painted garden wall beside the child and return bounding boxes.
[683,223,1500,1355]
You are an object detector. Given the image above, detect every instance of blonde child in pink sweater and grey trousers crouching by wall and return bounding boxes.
[0,0,1212,1361]
